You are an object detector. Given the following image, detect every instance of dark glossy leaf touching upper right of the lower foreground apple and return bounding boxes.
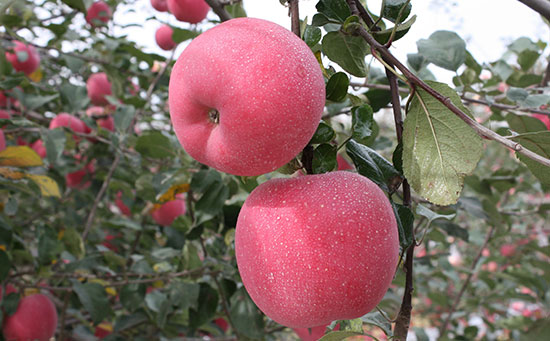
[346,140,403,193]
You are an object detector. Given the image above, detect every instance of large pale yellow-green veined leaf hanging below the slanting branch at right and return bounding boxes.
[403,81,482,205]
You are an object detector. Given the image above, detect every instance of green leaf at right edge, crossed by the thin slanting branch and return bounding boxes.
[512,131,550,186]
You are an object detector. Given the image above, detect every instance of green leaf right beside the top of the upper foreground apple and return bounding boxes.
[322,31,369,77]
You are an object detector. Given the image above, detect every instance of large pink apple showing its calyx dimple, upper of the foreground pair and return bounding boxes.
[169,18,325,176]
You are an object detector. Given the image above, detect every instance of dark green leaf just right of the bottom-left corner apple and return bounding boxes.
[72,280,113,325]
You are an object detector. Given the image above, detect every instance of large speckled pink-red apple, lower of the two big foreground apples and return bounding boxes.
[235,171,399,328]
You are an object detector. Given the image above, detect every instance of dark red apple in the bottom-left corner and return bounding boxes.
[2,294,57,341]
